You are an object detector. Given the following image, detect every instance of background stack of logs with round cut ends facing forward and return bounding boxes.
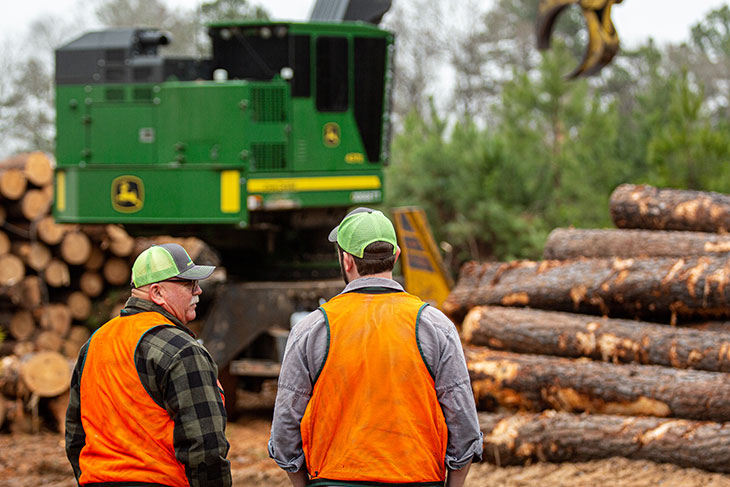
[0,152,218,432]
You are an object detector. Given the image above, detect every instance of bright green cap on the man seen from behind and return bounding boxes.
[328,208,398,259]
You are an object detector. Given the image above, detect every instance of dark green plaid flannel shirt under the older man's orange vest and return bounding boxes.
[66,298,231,487]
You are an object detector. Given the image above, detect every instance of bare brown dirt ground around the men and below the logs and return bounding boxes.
[0,386,730,487]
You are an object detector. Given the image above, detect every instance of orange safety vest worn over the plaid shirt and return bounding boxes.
[79,312,189,487]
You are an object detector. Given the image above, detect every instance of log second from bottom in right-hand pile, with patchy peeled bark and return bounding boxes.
[465,348,730,421]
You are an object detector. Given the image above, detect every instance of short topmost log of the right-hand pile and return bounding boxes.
[610,184,730,233]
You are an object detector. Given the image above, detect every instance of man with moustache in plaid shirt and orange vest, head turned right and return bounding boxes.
[66,244,231,487]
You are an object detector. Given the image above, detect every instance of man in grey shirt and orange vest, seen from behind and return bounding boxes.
[269,208,482,487]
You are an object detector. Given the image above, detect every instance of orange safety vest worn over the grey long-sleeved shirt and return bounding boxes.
[301,292,448,485]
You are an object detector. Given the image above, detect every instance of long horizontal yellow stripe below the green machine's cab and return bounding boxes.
[246,176,382,193]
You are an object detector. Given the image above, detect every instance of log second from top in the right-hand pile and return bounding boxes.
[543,228,730,260]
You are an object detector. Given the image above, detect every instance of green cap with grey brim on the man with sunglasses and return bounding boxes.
[132,244,215,287]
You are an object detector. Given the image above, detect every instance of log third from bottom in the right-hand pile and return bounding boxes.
[462,306,730,372]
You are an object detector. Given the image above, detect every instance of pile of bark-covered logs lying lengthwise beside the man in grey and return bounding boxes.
[444,185,730,473]
